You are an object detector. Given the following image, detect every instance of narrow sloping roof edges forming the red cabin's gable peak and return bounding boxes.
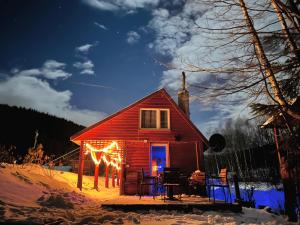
[70,88,208,145]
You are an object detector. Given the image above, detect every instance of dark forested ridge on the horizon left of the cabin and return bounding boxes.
[0,104,84,156]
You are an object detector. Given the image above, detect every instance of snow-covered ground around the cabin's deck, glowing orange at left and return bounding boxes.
[0,164,291,225]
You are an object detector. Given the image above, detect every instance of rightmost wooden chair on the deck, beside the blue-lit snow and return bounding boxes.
[207,168,232,203]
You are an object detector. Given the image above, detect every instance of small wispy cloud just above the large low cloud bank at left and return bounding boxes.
[12,60,71,80]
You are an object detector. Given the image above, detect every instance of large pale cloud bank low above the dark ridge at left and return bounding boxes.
[0,60,105,126]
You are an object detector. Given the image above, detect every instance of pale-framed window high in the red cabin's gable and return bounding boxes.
[140,109,170,129]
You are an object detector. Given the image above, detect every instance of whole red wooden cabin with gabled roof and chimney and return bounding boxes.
[71,77,208,194]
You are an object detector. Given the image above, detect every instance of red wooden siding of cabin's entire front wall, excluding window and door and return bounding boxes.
[71,89,207,194]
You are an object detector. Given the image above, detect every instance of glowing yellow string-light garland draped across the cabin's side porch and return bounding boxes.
[85,141,122,170]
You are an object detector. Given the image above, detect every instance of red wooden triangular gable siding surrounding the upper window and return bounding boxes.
[73,90,206,141]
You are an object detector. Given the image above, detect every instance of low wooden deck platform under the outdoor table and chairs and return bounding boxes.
[101,196,242,212]
